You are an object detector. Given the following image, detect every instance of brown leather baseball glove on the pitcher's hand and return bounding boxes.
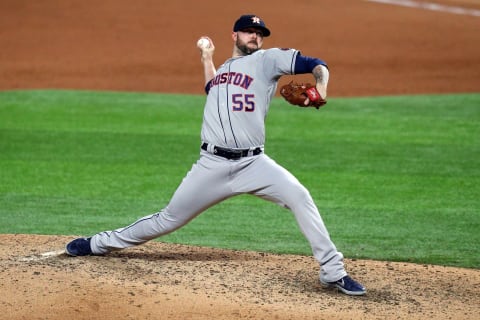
[280,80,327,109]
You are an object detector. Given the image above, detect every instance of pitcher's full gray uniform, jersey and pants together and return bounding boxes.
[91,49,347,281]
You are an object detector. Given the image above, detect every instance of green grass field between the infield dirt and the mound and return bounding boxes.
[0,90,480,268]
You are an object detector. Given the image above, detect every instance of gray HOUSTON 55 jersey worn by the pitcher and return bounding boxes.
[202,49,298,148]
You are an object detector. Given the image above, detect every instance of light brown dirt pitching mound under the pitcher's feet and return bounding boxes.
[0,235,480,320]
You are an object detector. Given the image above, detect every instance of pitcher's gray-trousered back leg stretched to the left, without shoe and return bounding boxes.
[90,156,231,254]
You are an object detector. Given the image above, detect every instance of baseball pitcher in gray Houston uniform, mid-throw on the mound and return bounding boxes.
[66,14,366,295]
